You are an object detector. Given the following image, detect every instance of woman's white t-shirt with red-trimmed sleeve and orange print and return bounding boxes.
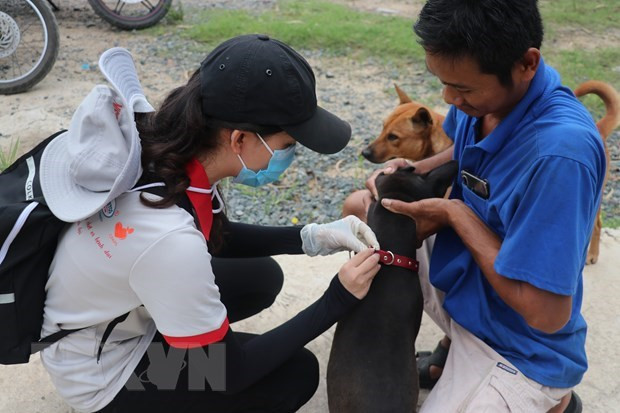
[41,193,228,412]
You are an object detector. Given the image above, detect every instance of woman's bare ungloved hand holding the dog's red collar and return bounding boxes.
[338,248,381,300]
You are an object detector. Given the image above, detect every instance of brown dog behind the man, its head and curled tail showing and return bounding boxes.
[362,80,620,264]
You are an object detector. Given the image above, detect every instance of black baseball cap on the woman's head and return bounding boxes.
[200,34,351,154]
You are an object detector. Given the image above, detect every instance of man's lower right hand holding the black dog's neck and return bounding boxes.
[381,198,453,248]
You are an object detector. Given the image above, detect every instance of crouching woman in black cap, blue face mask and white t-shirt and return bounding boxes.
[41,35,379,412]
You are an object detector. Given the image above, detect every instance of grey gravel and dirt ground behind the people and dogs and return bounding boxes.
[0,0,620,225]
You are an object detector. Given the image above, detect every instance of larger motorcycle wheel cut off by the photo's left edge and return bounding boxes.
[0,0,59,95]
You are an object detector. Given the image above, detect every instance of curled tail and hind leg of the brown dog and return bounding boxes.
[575,80,620,264]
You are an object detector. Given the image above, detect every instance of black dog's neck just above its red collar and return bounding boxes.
[368,202,416,259]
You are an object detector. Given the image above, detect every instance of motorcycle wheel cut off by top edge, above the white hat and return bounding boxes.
[88,0,172,30]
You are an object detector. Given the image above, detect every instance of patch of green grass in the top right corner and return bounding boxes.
[540,0,620,33]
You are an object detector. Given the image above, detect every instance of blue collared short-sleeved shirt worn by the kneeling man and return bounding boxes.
[430,61,605,387]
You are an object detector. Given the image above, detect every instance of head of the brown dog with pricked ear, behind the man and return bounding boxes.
[362,85,452,163]
